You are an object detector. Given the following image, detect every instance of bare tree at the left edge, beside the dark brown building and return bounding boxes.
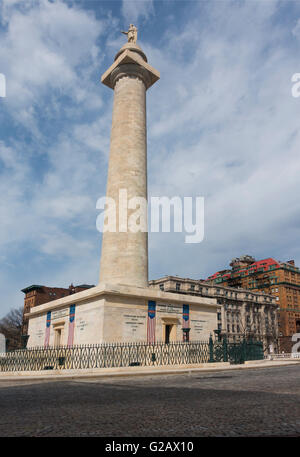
[0,308,23,350]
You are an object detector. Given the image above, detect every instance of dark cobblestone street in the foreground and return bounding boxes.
[0,365,300,437]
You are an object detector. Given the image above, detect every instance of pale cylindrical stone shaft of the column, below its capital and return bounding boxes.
[100,75,148,287]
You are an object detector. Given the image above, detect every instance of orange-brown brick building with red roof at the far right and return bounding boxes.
[207,255,300,352]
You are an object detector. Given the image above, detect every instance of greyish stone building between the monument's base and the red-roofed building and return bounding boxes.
[149,276,278,352]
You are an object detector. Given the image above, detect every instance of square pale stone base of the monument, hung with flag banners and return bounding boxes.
[27,283,218,348]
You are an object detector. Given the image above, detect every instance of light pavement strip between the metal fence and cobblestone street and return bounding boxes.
[0,359,300,386]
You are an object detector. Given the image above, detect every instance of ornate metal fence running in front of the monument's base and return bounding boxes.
[0,338,263,371]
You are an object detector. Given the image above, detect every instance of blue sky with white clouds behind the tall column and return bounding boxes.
[0,0,300,317]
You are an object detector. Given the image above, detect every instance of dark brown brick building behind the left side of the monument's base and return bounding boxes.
[22,284,94,335]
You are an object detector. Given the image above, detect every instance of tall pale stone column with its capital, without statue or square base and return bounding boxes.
[100,43,159,287]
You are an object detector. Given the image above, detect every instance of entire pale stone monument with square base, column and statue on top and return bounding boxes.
[26,24,218,347]
